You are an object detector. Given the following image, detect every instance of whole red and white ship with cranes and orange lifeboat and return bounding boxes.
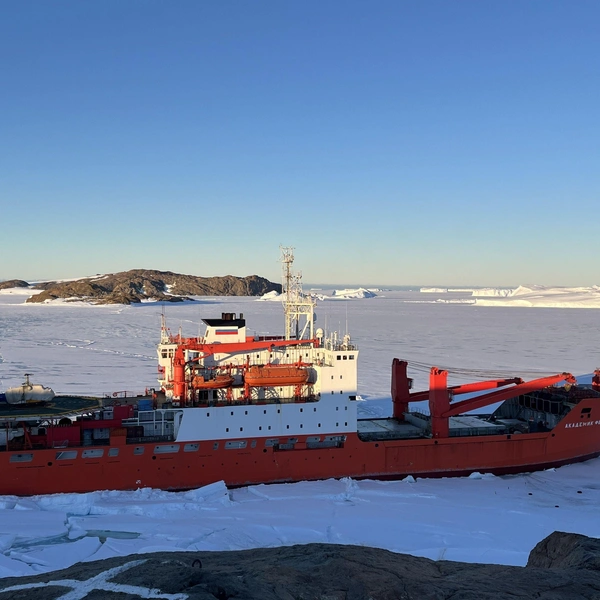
[0,248,600,495]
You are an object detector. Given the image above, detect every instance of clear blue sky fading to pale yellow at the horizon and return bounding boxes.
[0,0,600,286]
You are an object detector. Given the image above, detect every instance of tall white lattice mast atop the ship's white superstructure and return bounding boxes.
[280,246,315,340]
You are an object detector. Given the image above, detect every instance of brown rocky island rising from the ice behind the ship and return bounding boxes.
[23,269,281,304]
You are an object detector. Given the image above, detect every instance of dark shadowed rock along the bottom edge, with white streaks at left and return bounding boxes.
[0,532,600,600]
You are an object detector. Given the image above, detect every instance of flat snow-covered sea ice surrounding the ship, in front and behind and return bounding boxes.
[0,292,600,576]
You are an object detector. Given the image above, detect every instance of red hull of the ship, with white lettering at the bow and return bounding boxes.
[0,398,600,495]
